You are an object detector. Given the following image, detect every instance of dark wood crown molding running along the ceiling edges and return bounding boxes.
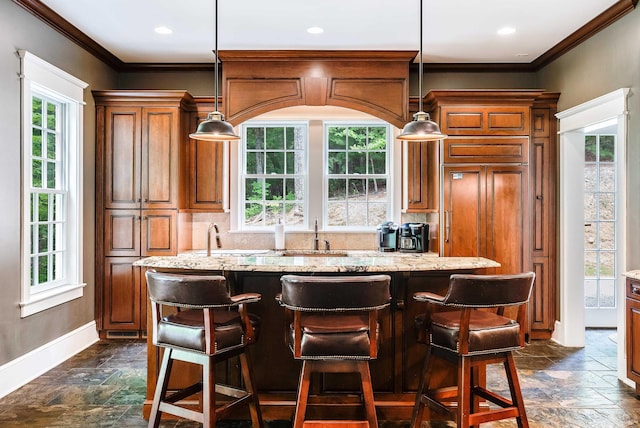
[13,0,639,73]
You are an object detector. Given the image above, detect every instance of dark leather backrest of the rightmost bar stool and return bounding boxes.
[442,272,535,308]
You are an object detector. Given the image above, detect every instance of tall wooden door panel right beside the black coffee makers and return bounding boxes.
[443,166,486,257]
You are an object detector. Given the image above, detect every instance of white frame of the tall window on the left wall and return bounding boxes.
[18,50,88,317]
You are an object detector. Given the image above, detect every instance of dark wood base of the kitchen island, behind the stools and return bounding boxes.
[144,269,479,420]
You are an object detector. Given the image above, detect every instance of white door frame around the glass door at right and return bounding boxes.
[553,88,629,381]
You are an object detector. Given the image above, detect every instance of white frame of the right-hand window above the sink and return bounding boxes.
[322,120,394,232]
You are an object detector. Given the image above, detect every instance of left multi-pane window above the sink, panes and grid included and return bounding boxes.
[240,122,308,229]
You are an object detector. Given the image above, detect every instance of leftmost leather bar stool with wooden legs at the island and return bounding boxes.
[146,271,263,428]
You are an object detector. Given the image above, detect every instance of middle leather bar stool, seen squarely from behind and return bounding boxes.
[277,275,391,428]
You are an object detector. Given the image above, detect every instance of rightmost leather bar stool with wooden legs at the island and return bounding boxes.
[412,272,535,428]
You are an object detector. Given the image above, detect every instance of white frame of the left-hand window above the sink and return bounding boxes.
[237,120,310,231]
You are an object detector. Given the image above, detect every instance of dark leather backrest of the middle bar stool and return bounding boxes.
[279,275,391,312]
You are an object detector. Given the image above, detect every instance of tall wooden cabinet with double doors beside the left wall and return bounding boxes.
[93,91,195,337]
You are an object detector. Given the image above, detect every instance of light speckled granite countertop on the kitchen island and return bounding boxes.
[134,250,500,272]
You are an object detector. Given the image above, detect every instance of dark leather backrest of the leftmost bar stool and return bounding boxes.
[146,270,233,308]
